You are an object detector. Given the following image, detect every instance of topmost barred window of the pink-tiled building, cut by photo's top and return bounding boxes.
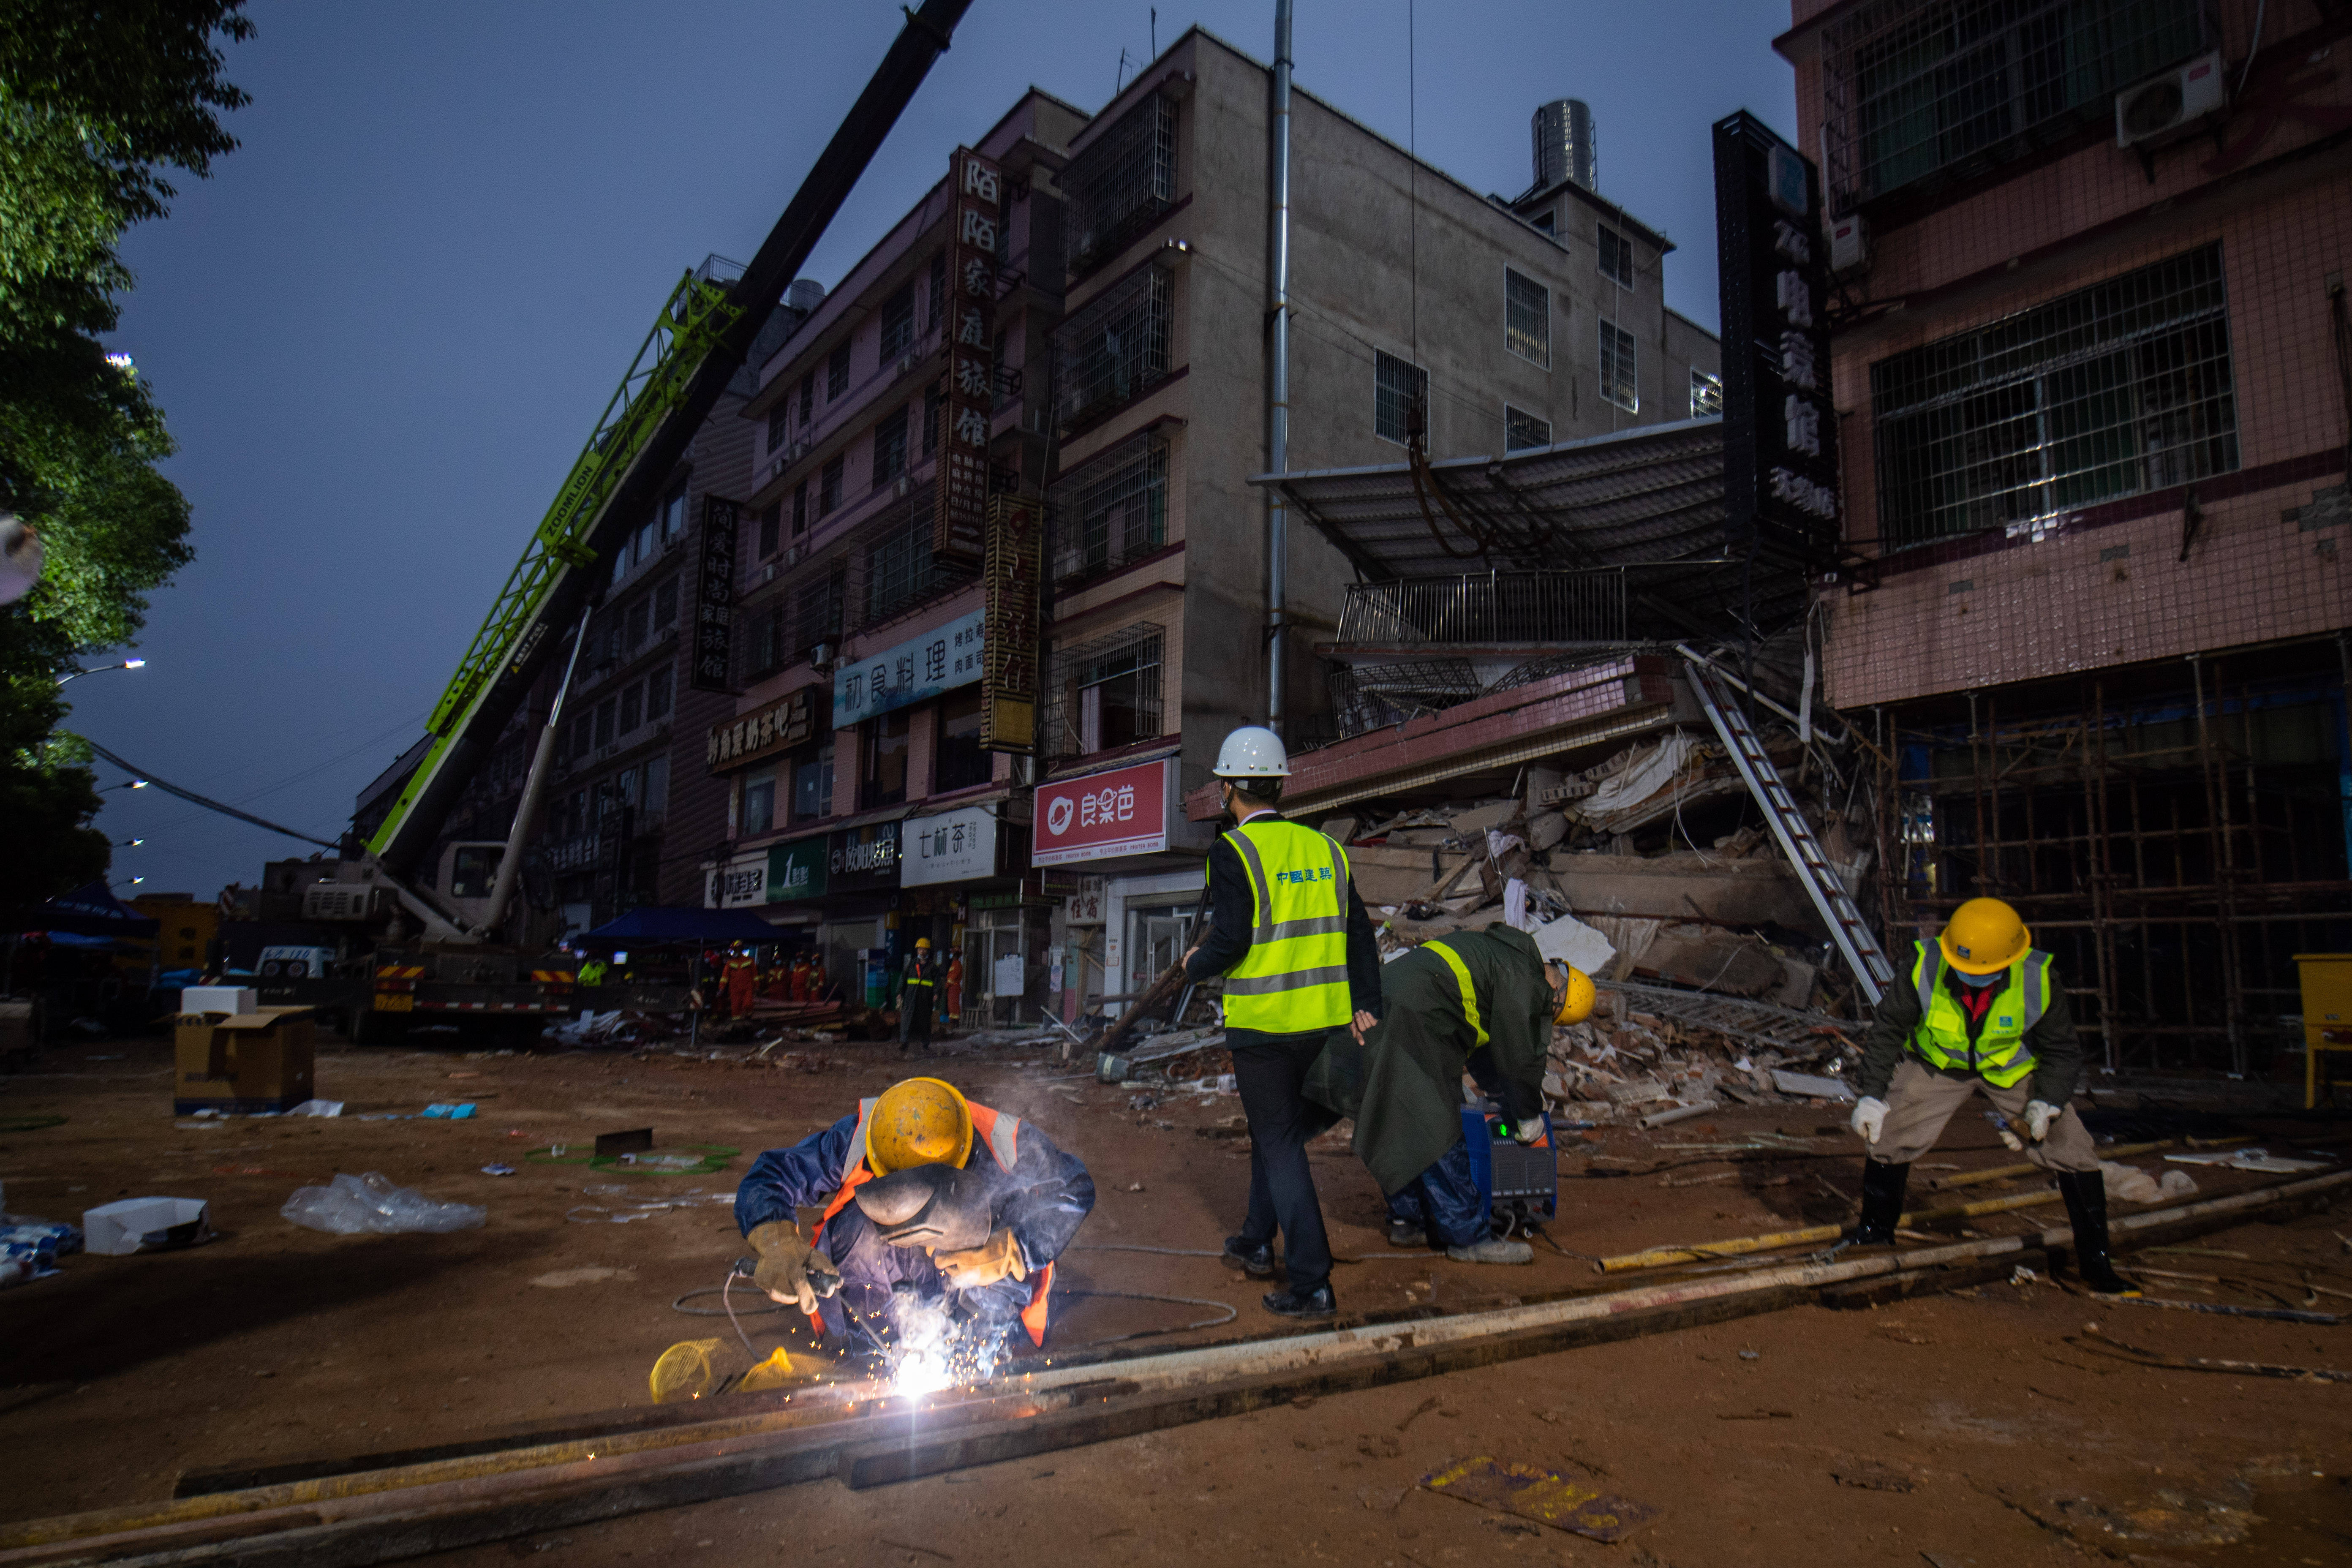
[1823,0,2206,212]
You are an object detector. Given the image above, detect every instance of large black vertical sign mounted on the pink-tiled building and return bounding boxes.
[1715,113,1839,564]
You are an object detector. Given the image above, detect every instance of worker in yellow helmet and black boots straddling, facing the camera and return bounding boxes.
[1848,898,2138,1295]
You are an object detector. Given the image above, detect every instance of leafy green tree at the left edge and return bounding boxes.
[0,0,254,903]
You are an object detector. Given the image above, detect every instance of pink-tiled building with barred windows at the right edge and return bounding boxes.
[1778,0,2352,1074]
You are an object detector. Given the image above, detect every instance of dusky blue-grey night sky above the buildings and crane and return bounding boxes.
[68,0,1794,898]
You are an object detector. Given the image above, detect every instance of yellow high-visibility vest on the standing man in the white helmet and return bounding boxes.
[1225,816,1355,1034]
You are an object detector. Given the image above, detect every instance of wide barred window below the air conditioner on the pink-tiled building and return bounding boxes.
[1870,245,2239,548]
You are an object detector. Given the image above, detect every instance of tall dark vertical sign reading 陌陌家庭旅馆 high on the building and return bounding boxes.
[931,148,1004,566]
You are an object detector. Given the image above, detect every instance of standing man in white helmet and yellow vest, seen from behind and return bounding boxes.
[1185,724,1380,1317]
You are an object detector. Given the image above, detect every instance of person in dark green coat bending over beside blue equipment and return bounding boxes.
[1308,922,1592,1263]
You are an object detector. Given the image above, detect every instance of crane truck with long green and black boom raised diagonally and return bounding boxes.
[284,0,972,1037]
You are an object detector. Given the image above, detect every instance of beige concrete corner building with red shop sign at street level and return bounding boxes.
[1035,28,1717,1025]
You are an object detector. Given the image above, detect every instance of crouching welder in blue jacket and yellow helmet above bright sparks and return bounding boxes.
[736,1079,1094,1349]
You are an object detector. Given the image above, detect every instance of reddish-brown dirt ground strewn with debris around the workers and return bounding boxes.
[0,1039,2352,1568]
